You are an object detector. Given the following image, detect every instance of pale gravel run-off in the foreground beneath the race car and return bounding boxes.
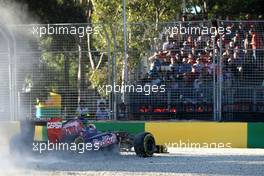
[0,149,264,176]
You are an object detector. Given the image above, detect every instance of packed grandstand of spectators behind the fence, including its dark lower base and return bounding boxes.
[128,20,264,121]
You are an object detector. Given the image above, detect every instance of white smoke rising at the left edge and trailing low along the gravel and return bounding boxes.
[0,0,124,176]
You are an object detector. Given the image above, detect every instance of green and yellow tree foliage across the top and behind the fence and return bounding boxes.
[5,0,262,114]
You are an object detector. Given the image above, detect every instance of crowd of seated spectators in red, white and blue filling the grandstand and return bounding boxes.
[143,15,264,93]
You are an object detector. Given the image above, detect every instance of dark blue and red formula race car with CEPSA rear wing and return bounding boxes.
[10,118,167,157]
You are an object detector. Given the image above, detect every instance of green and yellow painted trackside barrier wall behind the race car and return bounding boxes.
[6,121,264,148]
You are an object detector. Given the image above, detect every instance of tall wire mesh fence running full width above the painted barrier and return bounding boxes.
[0,20,264,121]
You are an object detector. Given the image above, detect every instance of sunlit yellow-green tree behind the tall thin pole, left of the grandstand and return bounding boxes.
[88,0,180,91]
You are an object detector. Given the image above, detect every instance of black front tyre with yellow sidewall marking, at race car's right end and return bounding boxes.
[134,132,156,157]
